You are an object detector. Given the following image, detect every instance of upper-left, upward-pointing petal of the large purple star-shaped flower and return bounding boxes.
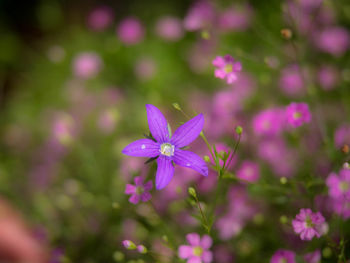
[146,104,169,143]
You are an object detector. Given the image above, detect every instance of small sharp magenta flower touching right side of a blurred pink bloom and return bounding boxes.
[286,102,311,127]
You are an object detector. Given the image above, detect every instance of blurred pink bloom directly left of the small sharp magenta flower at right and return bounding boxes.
[253,108,285,136]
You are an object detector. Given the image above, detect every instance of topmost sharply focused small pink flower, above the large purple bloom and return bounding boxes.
[213,55,242,84]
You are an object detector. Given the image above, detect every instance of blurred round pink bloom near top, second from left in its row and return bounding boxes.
[117,17,145,45]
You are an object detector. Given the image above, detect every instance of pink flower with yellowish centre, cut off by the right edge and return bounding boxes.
[326,168,350,200]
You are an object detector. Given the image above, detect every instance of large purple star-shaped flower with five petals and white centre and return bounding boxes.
[122,104,208,190]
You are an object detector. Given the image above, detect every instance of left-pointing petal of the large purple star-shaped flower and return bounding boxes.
[122,139,159,157]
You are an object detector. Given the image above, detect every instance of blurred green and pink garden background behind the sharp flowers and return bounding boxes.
[0,0,350,263]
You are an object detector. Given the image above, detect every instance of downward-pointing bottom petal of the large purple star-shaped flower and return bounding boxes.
[156,155,174,190]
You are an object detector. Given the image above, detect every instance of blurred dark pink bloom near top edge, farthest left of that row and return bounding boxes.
[87,6,114,31]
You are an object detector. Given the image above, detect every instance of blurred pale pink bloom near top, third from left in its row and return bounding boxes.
[155,16,184,41]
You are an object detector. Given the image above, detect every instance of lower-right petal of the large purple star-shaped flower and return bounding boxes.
[173,149,208,176]
